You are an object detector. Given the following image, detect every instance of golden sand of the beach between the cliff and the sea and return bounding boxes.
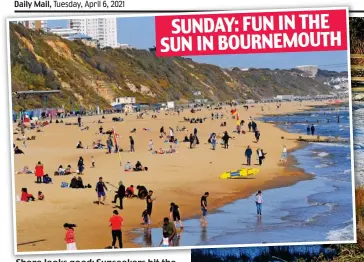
[14,102,332,252]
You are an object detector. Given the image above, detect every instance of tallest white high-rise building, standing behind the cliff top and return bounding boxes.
[68,17,118,48]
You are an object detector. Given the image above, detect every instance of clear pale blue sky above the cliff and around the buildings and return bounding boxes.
[48,16,348,71]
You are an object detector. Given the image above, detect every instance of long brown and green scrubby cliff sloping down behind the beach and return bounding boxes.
[10,24,332,110]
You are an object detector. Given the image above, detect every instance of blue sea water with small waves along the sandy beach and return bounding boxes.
[135,106,354,247]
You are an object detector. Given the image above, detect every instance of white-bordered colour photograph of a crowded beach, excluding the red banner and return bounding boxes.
[8,11,356,253]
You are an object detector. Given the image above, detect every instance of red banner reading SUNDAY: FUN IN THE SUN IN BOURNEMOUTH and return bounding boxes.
[155,9,348,56]
